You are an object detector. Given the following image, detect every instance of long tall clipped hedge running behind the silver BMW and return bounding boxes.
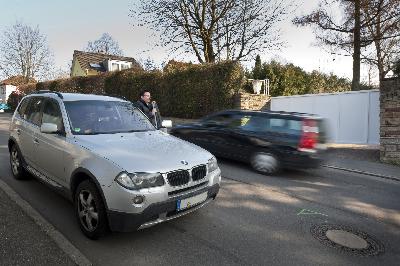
[20,61,244,118]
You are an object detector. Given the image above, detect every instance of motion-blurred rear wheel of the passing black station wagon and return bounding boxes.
[250,152,280,175]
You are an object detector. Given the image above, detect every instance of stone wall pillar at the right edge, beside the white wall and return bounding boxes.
[380,78,400,165]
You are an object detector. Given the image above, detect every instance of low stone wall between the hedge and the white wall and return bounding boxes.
[234,93,271,110]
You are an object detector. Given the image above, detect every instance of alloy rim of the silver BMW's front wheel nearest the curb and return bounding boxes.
[78,190,99,232]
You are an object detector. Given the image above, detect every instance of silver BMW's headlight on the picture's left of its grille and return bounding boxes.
[115,172,165,190]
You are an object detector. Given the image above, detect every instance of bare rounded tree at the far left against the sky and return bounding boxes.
[0,22,54,80]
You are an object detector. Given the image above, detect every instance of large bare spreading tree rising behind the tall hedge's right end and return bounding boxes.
[131,0,290,63]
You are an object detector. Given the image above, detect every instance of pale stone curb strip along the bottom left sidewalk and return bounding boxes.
[0,180,92,266]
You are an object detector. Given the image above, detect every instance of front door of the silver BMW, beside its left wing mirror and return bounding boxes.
[36,98,68,185]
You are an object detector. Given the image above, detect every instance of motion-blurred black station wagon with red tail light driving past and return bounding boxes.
[170,110,326,174]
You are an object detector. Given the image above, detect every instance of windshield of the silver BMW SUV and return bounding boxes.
[64,100,155,135]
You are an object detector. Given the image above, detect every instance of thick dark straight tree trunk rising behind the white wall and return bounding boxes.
[351,0,361,91]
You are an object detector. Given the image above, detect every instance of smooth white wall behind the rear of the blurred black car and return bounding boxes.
[271,90,380,144]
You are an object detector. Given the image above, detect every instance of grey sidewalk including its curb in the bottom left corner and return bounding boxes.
[0,179,91,265]
